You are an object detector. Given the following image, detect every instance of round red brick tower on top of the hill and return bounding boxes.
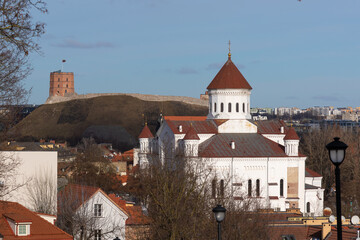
[49,71,74,97]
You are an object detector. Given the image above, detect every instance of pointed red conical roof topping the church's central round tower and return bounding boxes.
[207,57,252,90]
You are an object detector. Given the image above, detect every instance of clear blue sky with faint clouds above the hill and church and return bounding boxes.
[25,0,360,108]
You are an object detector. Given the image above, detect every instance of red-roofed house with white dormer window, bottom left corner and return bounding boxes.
[0,201,73,240]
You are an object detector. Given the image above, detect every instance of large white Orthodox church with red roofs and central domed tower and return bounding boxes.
[139,50,324,216]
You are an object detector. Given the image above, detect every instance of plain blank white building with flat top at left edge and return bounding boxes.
[0,146,57,214]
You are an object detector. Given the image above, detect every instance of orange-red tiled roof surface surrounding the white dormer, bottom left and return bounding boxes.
[0,201,73,240]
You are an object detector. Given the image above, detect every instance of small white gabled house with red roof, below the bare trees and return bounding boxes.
[58,184,129,240]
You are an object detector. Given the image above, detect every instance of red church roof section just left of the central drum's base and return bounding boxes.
[165,117,217,134]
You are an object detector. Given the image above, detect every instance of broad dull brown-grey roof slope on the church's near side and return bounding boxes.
[199,133,287,157]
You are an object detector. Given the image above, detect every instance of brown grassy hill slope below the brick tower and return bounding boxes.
[12,95,208,150]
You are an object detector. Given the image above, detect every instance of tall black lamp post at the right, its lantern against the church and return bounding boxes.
[326,137,348,240]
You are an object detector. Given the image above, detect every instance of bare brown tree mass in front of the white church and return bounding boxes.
[132,157,267,240]
